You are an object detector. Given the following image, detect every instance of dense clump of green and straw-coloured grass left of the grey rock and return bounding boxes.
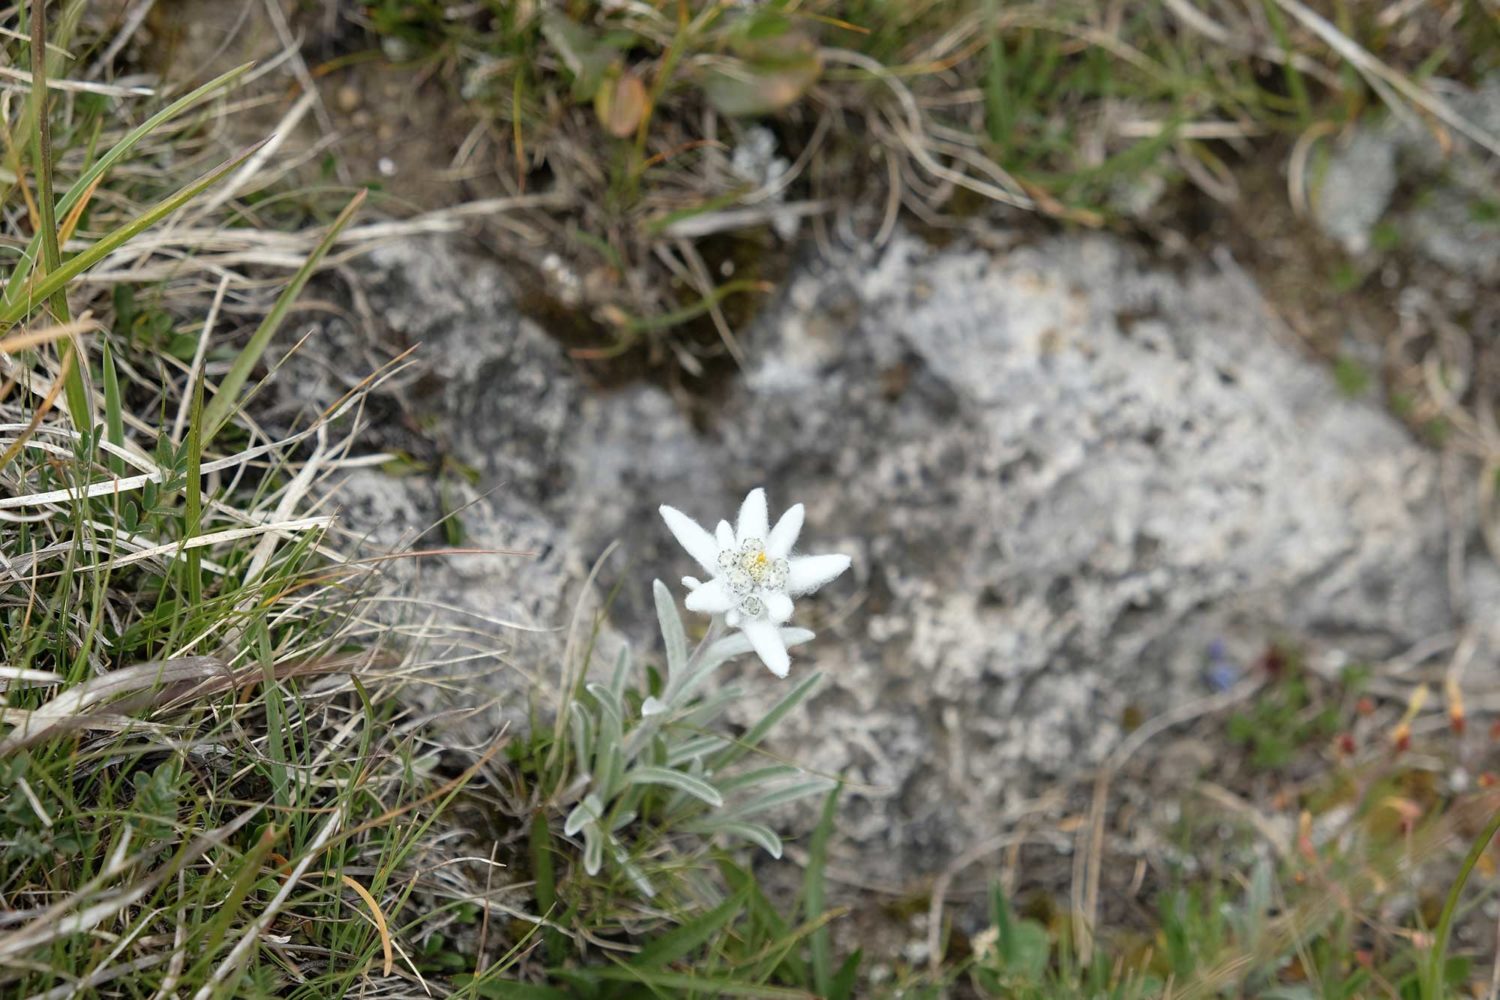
[0,11,504,997]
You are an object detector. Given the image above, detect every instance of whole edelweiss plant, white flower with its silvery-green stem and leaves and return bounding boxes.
[528,490,849,897]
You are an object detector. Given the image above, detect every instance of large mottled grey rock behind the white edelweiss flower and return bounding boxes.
[313,235,1454,880]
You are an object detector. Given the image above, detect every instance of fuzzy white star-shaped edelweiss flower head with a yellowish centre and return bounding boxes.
[662,489,849,678]
